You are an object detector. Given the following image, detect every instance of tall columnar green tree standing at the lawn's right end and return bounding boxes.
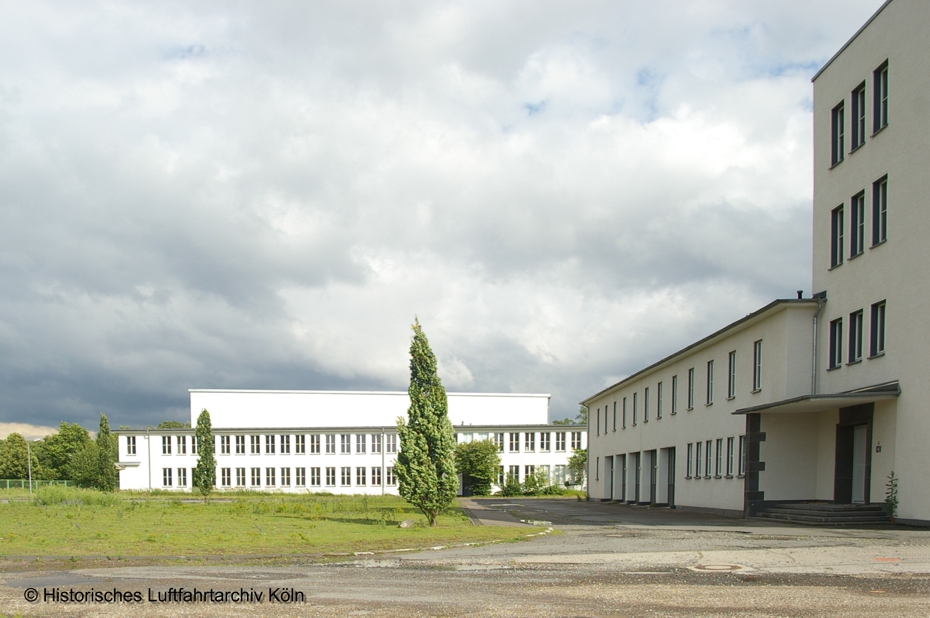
[394,320,458,526]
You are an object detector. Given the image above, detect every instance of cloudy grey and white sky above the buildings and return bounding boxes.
[0,0,881,435]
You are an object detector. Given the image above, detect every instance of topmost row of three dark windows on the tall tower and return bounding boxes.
[830,60,888,165]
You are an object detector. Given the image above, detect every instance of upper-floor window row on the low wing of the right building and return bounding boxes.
[595,339,762,435]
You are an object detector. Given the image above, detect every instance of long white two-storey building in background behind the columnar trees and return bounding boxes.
[114,390,587,494]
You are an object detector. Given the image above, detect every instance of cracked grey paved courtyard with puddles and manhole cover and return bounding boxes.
[0,498,930,616]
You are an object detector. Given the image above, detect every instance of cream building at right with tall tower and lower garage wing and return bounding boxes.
[583,0,930,524]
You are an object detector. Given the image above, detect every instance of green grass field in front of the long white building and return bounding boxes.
[0,488,537,557]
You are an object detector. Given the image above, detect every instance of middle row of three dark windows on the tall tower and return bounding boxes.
[830,175,888,268]
